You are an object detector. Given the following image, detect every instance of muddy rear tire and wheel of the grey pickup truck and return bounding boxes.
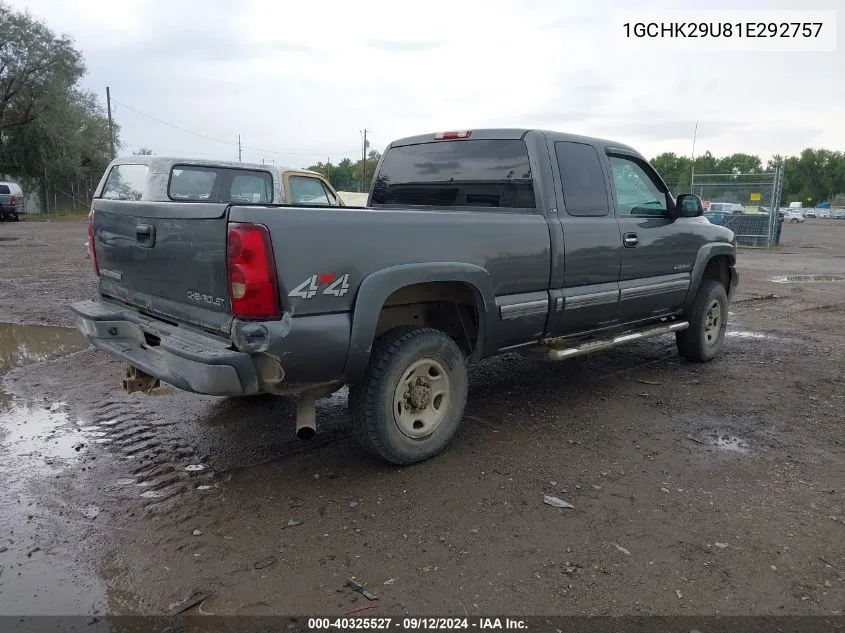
[349,327,469,465]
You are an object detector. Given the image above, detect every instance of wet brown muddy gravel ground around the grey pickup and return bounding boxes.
[0,221,845,615]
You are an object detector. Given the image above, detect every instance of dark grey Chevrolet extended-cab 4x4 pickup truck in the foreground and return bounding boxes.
[72,129,738,464]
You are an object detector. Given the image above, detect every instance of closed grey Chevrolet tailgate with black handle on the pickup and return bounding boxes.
[92,199,232,332]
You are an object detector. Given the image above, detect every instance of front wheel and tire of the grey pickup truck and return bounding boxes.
[675,279,728,363]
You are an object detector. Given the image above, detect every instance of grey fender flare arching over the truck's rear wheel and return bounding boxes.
[344,262,496,384]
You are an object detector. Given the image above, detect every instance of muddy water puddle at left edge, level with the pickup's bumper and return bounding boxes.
[0,323,88,374]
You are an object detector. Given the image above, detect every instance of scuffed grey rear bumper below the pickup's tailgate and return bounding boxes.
[71,301,260,396]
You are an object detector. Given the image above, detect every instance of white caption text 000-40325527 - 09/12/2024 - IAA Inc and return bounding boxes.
[308,617,528,631]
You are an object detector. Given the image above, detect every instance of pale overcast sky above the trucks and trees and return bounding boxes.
[11,0,845,167]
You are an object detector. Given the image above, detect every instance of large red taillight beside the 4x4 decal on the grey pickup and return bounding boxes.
[226,222,281,319]
